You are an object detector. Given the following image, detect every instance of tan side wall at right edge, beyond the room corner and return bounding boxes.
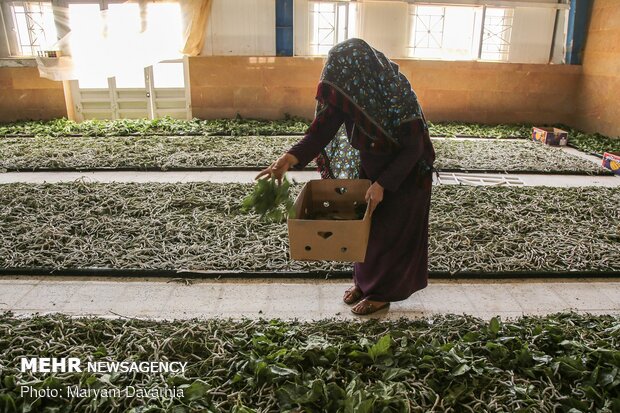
[572,0,620,136]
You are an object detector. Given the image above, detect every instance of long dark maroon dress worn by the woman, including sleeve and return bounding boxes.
[289,107,435,302]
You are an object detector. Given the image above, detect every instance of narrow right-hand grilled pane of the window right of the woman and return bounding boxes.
[480,7,514,60]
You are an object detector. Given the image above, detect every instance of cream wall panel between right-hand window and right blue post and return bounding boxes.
[508,7,555,63]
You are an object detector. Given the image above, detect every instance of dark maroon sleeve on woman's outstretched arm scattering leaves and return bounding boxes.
[288,106,345,169]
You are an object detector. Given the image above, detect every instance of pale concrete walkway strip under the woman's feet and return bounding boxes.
[0,276,620,320]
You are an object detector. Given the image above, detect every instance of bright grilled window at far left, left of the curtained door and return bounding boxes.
[8,1,58,56]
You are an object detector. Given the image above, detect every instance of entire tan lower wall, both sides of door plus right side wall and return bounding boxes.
[0,0,620,136]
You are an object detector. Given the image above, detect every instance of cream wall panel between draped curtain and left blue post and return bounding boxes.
[202,0,276,56]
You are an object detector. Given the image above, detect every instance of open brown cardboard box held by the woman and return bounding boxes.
[288,179,371,262]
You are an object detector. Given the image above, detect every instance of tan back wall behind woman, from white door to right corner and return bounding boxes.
[189,57,581,123]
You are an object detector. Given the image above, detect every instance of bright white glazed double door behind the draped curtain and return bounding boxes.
[62,2,191,121]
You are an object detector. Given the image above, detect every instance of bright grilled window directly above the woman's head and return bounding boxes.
[309,1,357,55]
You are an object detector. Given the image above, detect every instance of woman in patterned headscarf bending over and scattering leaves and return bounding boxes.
[257,39,435,315]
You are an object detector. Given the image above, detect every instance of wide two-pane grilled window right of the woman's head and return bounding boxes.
[409,5,513,61]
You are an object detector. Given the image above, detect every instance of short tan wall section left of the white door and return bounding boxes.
[0,67,67,122]
